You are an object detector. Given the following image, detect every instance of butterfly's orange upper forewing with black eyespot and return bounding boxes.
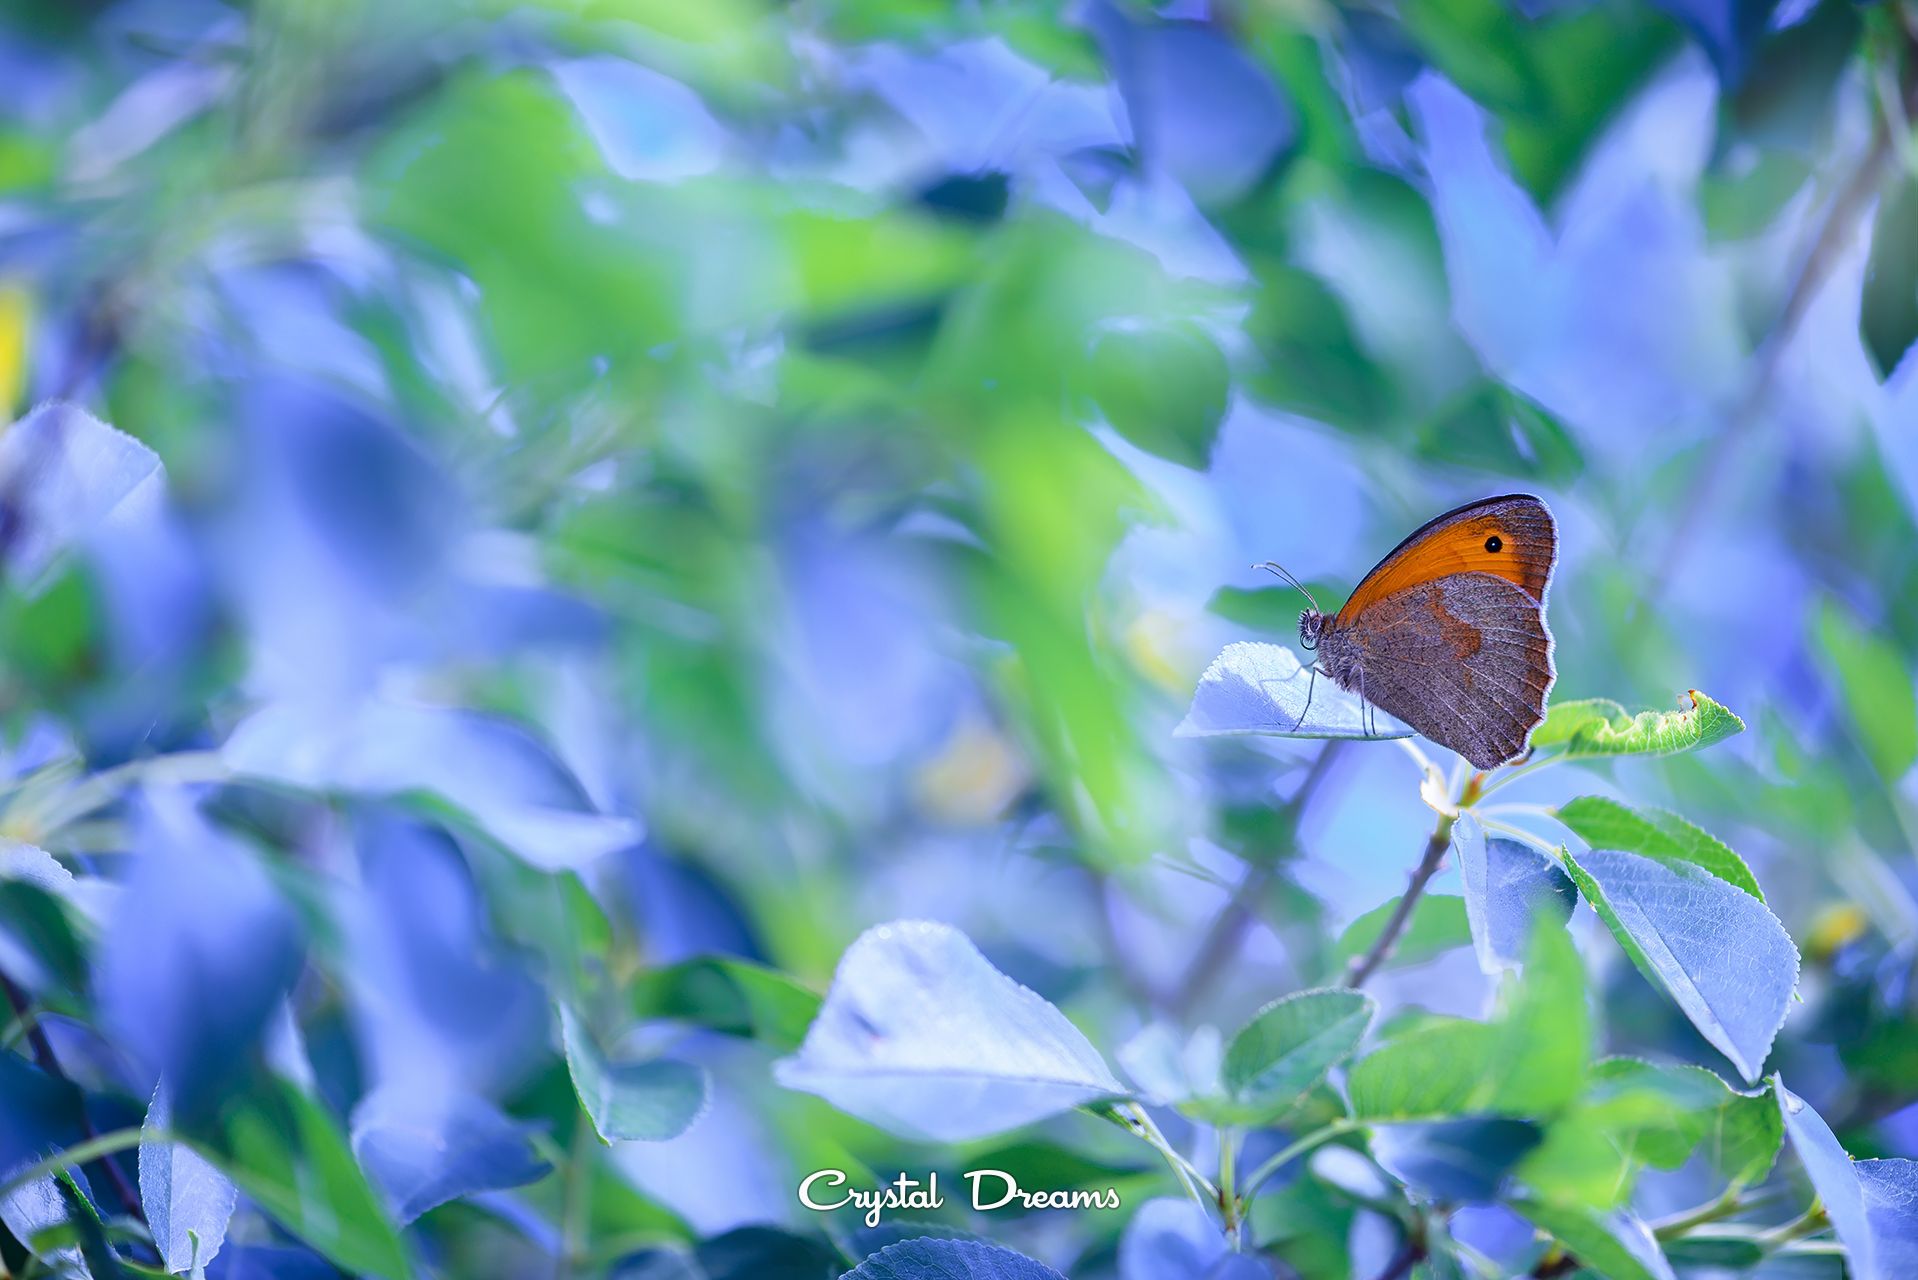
[1335,493,1557,628]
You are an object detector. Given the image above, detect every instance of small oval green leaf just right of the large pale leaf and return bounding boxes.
[1220,988,1377,1125]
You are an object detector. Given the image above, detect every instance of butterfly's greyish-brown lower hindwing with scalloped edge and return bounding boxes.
[1323,572,1557,770]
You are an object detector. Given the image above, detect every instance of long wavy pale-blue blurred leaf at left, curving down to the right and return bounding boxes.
[221,700,644,871]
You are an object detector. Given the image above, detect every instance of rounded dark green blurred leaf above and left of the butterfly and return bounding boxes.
[1088,322,1231,470]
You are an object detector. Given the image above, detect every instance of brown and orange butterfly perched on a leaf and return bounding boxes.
[1266,493,1557,770]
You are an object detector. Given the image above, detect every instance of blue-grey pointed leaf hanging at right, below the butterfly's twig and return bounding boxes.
[1565,850,1799,1082]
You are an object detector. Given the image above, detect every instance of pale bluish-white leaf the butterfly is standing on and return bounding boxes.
[1176,641,1412,739]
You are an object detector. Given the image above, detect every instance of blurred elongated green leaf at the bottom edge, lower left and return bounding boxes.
[207,1082,412,1280]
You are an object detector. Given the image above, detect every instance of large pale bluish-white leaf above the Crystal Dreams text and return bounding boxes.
[775,921,1126,1142]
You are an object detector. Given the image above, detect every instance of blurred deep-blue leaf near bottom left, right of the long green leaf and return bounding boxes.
[353,1090,550,1226]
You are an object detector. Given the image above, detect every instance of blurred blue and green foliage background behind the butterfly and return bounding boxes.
[0,0,1918,1280]
